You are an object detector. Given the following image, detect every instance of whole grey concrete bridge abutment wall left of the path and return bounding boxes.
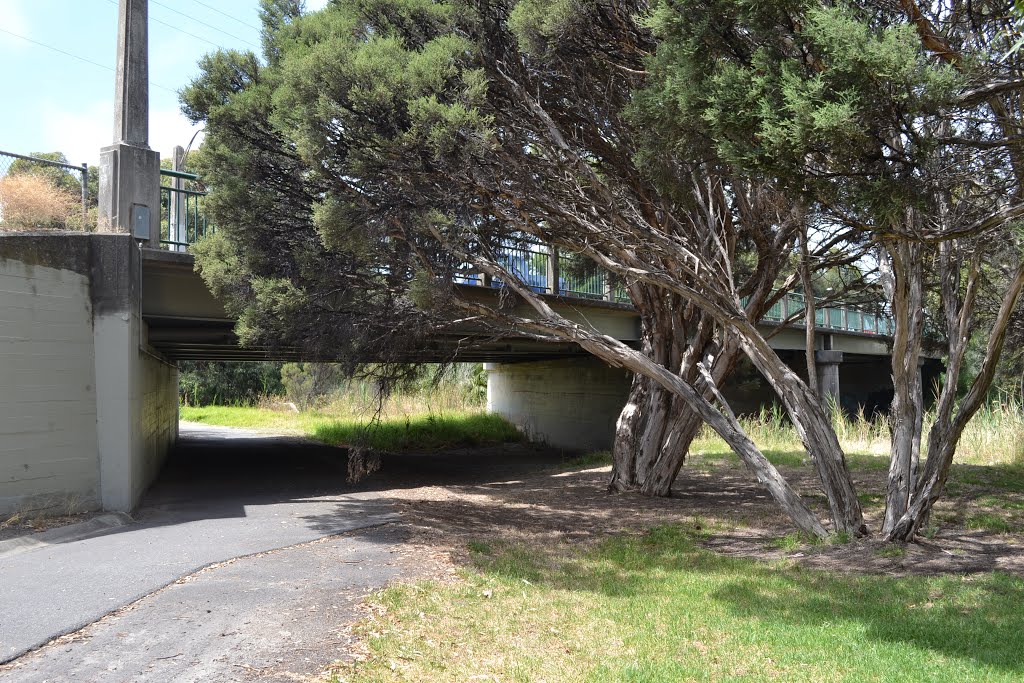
[0,233,178,513]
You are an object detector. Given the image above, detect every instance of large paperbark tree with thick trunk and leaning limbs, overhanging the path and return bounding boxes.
[184,0,880,535]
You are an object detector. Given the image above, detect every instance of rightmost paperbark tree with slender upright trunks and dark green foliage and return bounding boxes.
[638,0,1024,540]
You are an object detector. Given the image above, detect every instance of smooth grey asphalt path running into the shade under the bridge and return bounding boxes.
[0,425,397,663]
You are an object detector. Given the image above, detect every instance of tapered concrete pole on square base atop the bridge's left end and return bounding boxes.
[99,0,160,247]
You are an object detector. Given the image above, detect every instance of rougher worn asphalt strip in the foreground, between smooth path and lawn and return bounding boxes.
[0,525,408,683]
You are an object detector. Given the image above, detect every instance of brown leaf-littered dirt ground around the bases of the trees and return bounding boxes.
[360,446,1024,577]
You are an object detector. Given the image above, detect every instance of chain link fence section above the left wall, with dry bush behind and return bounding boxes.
[0,151,98,232]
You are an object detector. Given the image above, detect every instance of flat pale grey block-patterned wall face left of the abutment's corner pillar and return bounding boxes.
[0,253,99,512]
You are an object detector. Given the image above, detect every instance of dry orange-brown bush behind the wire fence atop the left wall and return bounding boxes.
[0,174,82,232]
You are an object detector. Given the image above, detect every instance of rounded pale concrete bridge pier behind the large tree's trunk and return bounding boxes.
[484,358,632,451]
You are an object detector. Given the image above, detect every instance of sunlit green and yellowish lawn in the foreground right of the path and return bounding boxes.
[337,526,1024,682]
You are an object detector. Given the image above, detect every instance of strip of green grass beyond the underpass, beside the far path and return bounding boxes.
[181,405,522,452]
